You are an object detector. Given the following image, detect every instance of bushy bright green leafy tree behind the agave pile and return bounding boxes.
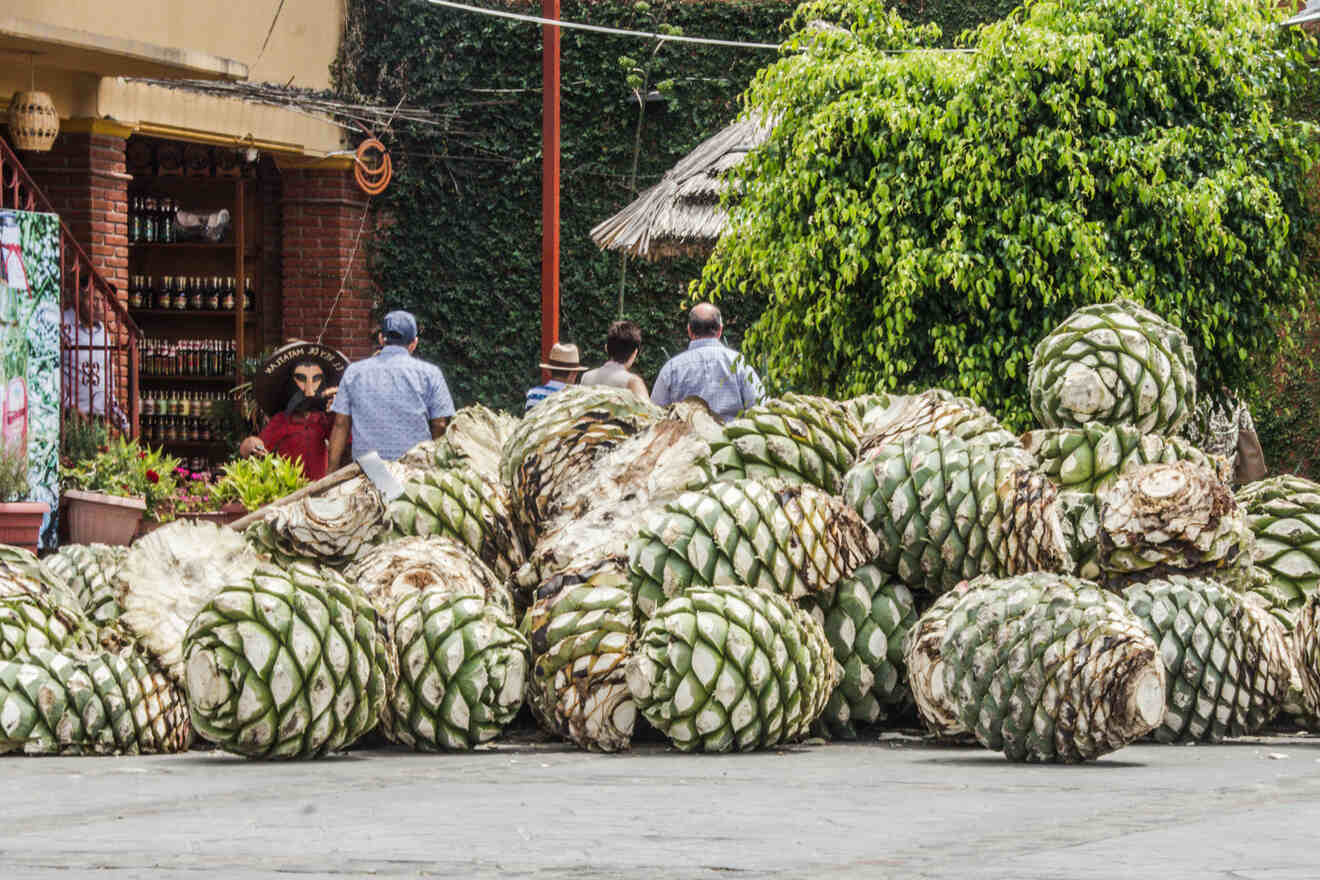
[693,0,1317,426]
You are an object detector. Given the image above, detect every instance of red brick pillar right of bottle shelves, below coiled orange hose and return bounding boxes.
[281,169,375,359]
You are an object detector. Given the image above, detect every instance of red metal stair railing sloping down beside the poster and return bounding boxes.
[0,137,143,437]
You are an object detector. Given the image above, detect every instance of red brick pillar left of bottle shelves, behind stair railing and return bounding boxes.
[20,119,132,305]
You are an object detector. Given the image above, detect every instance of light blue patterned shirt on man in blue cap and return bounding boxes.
[330,346,454,460]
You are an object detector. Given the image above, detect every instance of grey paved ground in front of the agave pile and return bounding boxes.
[0,735,1320,880]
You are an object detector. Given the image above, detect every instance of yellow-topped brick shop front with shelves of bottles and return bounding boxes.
[0,0,374,466]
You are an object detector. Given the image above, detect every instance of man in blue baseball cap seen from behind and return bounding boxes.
[329,311,454,471]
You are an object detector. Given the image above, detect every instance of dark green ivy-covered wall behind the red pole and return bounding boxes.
[335,0,1015,412]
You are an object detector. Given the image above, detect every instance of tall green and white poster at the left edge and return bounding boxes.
[0,211,59,548]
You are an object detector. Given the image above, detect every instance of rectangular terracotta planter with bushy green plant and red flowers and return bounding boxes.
[63,437,178,544]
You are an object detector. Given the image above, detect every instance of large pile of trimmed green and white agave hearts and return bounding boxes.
[0,301,1320,761]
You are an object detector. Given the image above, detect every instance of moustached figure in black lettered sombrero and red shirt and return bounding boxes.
[239,342,348,480]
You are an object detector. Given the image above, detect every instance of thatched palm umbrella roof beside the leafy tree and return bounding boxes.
[591,119,771,260]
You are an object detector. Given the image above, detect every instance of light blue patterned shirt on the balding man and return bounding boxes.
[651,339,766,422]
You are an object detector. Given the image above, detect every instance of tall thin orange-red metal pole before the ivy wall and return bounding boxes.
[541,0,560,381]
